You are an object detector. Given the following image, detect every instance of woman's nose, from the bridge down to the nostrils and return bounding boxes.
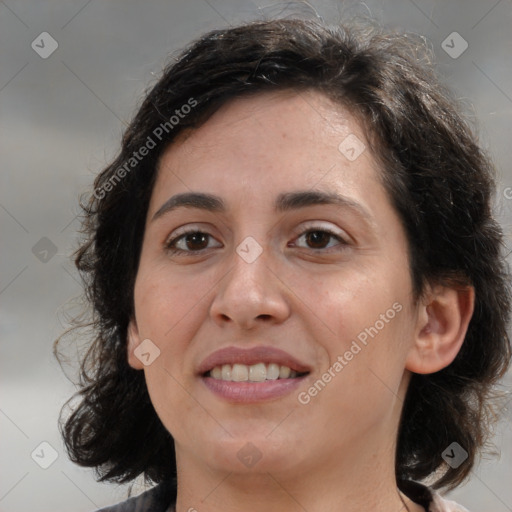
[210,246,290,330]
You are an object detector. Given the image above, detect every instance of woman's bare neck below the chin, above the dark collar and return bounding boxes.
[176,436,423,512]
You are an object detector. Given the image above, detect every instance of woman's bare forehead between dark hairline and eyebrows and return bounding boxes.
[154,91,379,212]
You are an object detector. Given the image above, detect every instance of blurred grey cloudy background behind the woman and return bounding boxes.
[0,0,512,512]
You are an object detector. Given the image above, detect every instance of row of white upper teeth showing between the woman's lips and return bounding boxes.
[209,363,304,382]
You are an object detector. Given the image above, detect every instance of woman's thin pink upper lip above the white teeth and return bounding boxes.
[198,346,310,375]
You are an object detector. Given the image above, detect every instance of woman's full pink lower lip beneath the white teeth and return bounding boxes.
[202,375,307,404]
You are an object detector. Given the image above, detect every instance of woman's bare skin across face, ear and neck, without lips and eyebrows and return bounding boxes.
[128,92,474,512]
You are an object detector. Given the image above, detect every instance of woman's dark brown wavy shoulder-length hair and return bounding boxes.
[56,19,511,488]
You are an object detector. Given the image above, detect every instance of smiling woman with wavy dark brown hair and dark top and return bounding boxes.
[57,20,510,512]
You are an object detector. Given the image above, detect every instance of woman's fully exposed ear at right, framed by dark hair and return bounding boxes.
[405,286,475,374]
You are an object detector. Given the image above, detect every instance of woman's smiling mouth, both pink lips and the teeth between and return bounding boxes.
[198,346,311,403]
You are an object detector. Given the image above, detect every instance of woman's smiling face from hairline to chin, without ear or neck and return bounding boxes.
[129,92,418,480]
